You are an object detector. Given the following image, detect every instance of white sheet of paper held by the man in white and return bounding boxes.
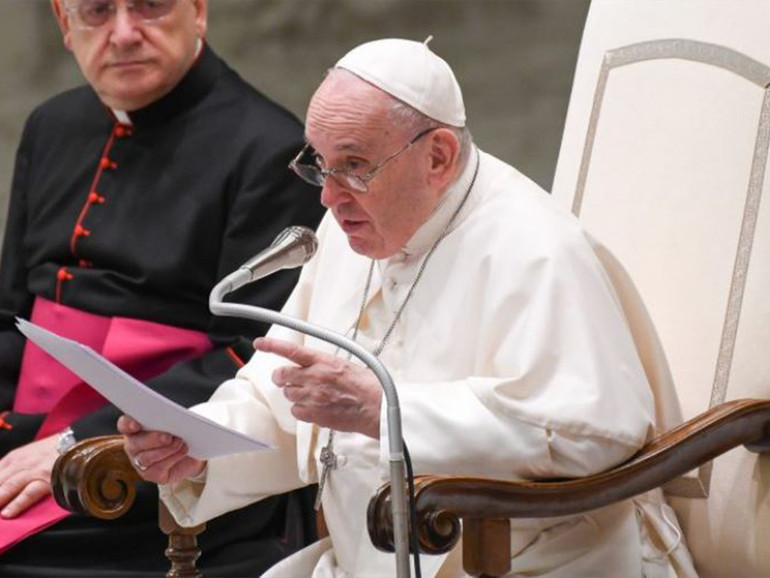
[16,319,272,459]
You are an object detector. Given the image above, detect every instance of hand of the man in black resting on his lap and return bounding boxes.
[0,435,59,518]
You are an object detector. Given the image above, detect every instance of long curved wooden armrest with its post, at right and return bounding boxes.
[368,399,770,576]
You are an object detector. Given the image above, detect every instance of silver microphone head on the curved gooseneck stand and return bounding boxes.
[223,226,318,293]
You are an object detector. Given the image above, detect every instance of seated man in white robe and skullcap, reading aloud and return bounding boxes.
[119,39,695,578]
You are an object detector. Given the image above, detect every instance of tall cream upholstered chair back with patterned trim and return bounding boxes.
[553,0,770,578]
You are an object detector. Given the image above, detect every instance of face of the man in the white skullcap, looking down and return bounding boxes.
[306,72,441,259]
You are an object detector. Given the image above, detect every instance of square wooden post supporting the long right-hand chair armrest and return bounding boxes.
[463,518,511,577]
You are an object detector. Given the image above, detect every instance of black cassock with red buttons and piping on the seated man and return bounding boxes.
[0,46,322,576]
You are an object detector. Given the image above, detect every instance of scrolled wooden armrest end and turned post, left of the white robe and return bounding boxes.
[51,435,206,578]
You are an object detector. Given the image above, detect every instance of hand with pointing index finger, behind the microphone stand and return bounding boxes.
[254,337,382,439]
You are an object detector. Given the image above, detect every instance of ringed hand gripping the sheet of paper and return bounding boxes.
[118,415,206,484]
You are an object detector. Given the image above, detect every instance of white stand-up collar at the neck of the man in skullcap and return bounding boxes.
[392,145,479,256]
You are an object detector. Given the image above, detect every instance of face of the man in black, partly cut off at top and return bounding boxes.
[52,0,207,111]
